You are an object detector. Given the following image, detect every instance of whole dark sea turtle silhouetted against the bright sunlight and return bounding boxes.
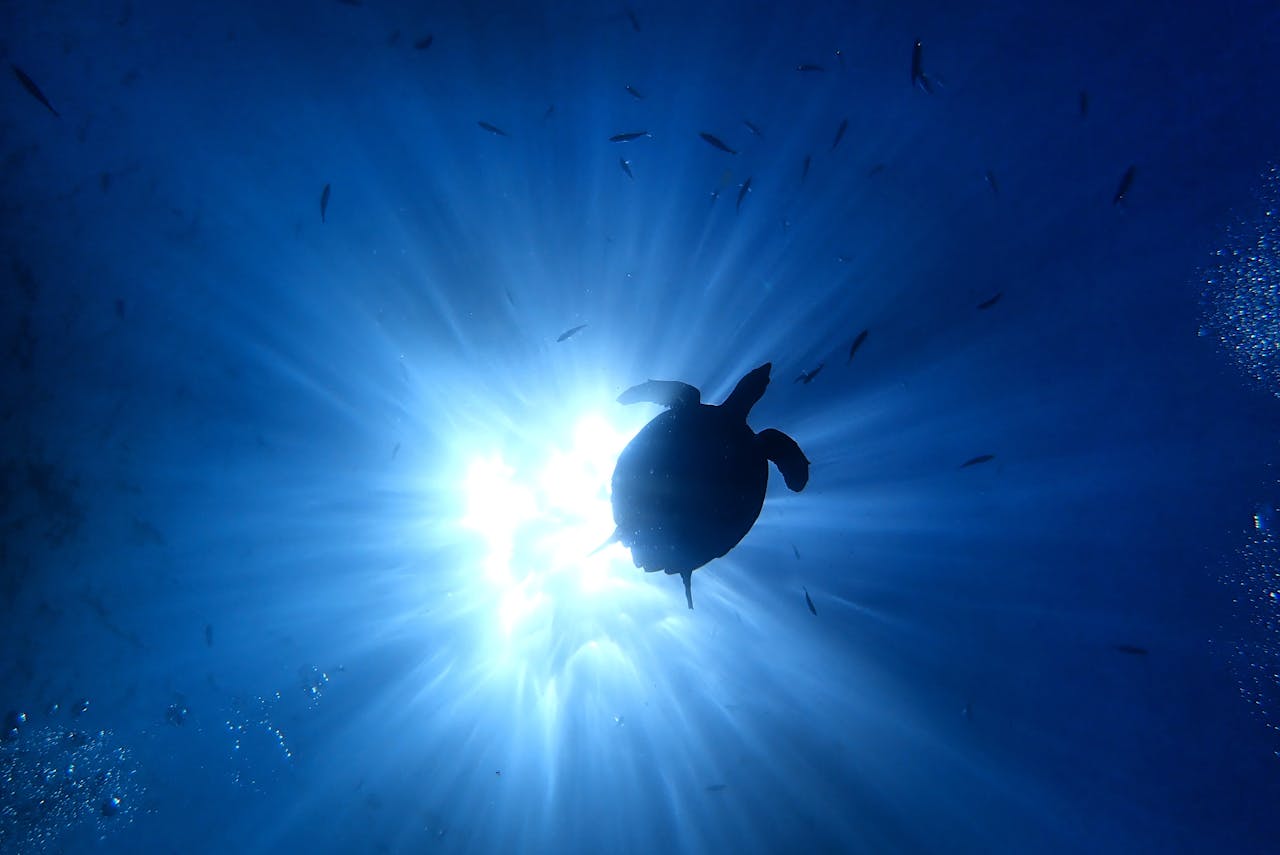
[609,362,809,608]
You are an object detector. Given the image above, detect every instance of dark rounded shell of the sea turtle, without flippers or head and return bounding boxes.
[612,403,769,573]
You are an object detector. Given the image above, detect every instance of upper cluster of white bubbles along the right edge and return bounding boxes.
[1201,166,1280,394]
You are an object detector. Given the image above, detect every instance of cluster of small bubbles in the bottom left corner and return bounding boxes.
[0,701,143,852]
